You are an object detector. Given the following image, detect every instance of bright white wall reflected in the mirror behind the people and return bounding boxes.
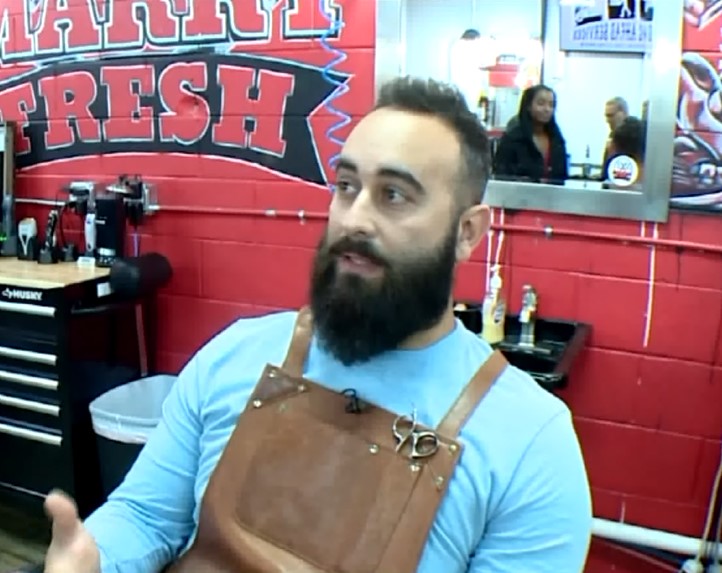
[396,0,648,163]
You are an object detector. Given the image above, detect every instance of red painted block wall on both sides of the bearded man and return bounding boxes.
[0,0,722,573]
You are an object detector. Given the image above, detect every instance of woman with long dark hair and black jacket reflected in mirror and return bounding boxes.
[494,84,568,183]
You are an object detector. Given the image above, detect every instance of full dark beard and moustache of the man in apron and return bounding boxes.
[311,225,456,366]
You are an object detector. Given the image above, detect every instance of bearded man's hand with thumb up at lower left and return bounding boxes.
[45,492,100,573]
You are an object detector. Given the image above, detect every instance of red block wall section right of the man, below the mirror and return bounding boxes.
[459,209,722,536]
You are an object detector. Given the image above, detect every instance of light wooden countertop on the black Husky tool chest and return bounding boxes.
[0,257,110,289]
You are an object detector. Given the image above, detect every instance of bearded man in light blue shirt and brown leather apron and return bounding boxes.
[39,78,592,573]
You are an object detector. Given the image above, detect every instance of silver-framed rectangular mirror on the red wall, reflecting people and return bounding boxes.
[376,0,684,221]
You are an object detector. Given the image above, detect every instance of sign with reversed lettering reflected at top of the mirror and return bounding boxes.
[559,0,654,53]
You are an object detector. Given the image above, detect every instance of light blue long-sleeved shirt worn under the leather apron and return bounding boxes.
[86,312,592,573]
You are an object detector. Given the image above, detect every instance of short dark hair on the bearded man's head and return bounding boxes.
[374,76,491,209]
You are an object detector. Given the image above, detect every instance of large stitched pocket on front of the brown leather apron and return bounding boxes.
[236,408,424,573]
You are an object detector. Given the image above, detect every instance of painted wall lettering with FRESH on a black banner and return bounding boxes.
[0,0,375,184]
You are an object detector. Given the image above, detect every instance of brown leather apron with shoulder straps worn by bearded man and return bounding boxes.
[168,309,507,573]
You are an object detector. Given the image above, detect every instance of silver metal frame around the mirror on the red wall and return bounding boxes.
[375,0,684,222]
